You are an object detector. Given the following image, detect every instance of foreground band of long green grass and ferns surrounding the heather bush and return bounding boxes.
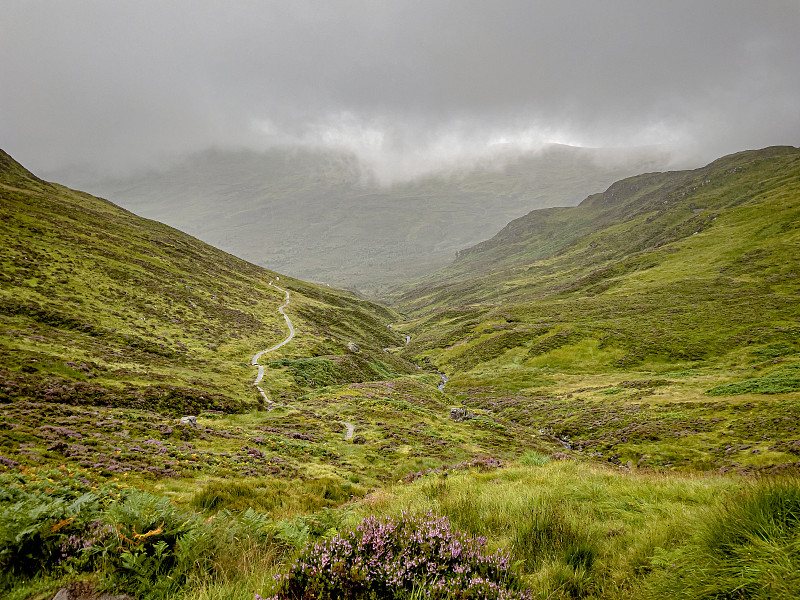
[0,453,800,600]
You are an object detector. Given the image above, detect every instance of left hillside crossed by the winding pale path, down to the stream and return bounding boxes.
[0,154,556,512]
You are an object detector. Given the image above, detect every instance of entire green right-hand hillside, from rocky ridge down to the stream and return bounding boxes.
[400,148,800,468]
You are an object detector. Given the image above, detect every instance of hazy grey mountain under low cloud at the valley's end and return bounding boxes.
[52,146,667,295]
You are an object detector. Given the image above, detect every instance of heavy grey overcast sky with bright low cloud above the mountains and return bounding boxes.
[0,0,800,177]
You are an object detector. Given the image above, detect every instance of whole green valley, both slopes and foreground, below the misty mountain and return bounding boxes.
[0,147,800,600]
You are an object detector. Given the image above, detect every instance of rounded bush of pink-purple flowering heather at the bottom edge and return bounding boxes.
[268,513,530,600]
